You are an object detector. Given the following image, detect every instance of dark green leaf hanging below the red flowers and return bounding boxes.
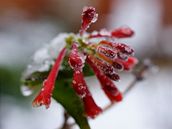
[53,80,90,129]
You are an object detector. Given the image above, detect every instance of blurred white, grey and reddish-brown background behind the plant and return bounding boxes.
[0,0,172,129]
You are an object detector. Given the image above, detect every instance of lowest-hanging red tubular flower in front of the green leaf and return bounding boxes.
[72,71,102,118]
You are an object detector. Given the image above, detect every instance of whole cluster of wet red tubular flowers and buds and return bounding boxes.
[29,7,137,118]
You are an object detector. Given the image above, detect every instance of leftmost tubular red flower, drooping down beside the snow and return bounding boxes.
[32,48,66,108]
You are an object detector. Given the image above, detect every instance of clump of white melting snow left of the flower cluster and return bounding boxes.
[24,33,69,77]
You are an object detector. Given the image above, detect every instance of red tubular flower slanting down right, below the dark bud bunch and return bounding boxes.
[87,57,122,102]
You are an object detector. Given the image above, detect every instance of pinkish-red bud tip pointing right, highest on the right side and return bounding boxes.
[111,27,134,38]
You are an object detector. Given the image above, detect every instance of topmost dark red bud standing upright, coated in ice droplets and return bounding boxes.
[80,7,98,35]
